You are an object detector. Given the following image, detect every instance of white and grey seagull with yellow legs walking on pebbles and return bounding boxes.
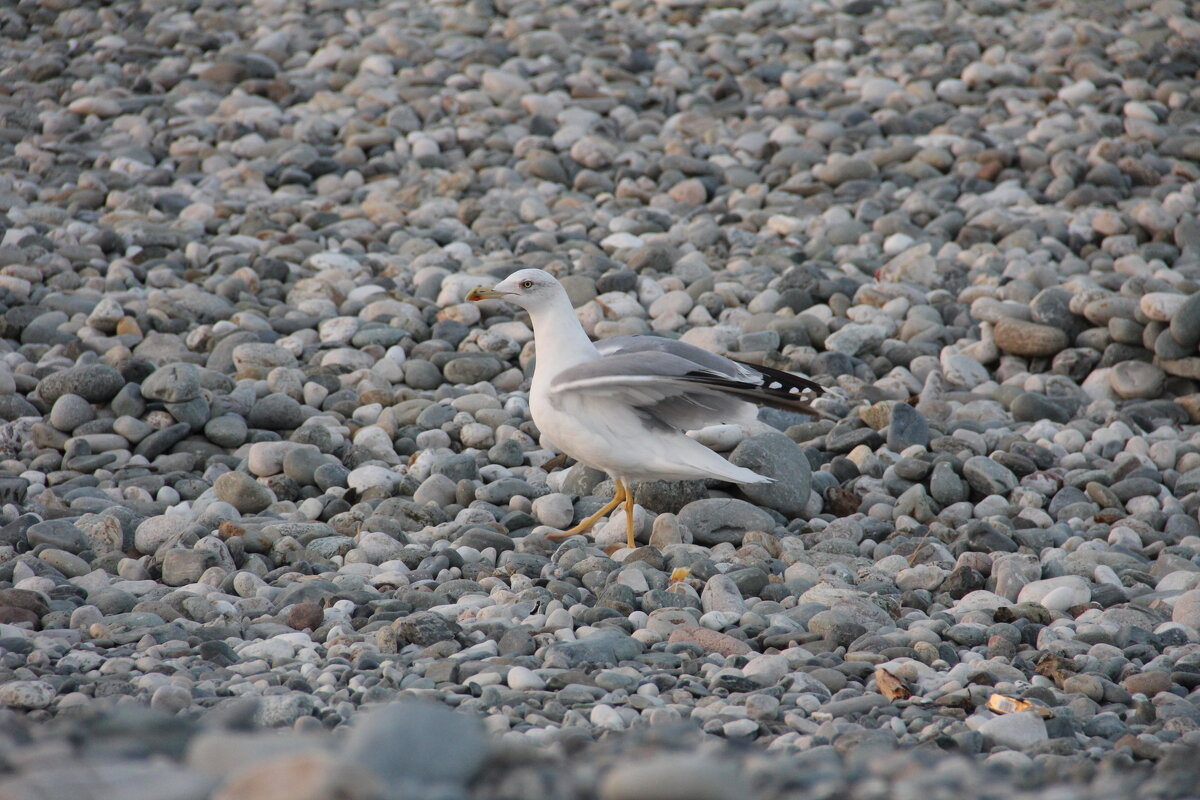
[467,270,824,548]
